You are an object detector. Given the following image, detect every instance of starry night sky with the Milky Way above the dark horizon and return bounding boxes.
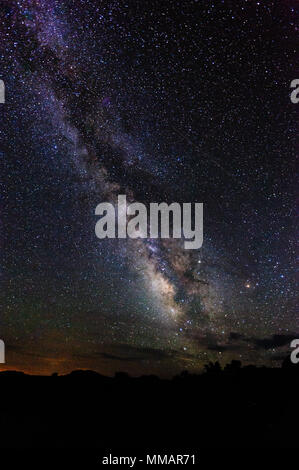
[0,0,299,376]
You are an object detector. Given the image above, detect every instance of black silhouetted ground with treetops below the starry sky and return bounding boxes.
[0,360,299,450]
